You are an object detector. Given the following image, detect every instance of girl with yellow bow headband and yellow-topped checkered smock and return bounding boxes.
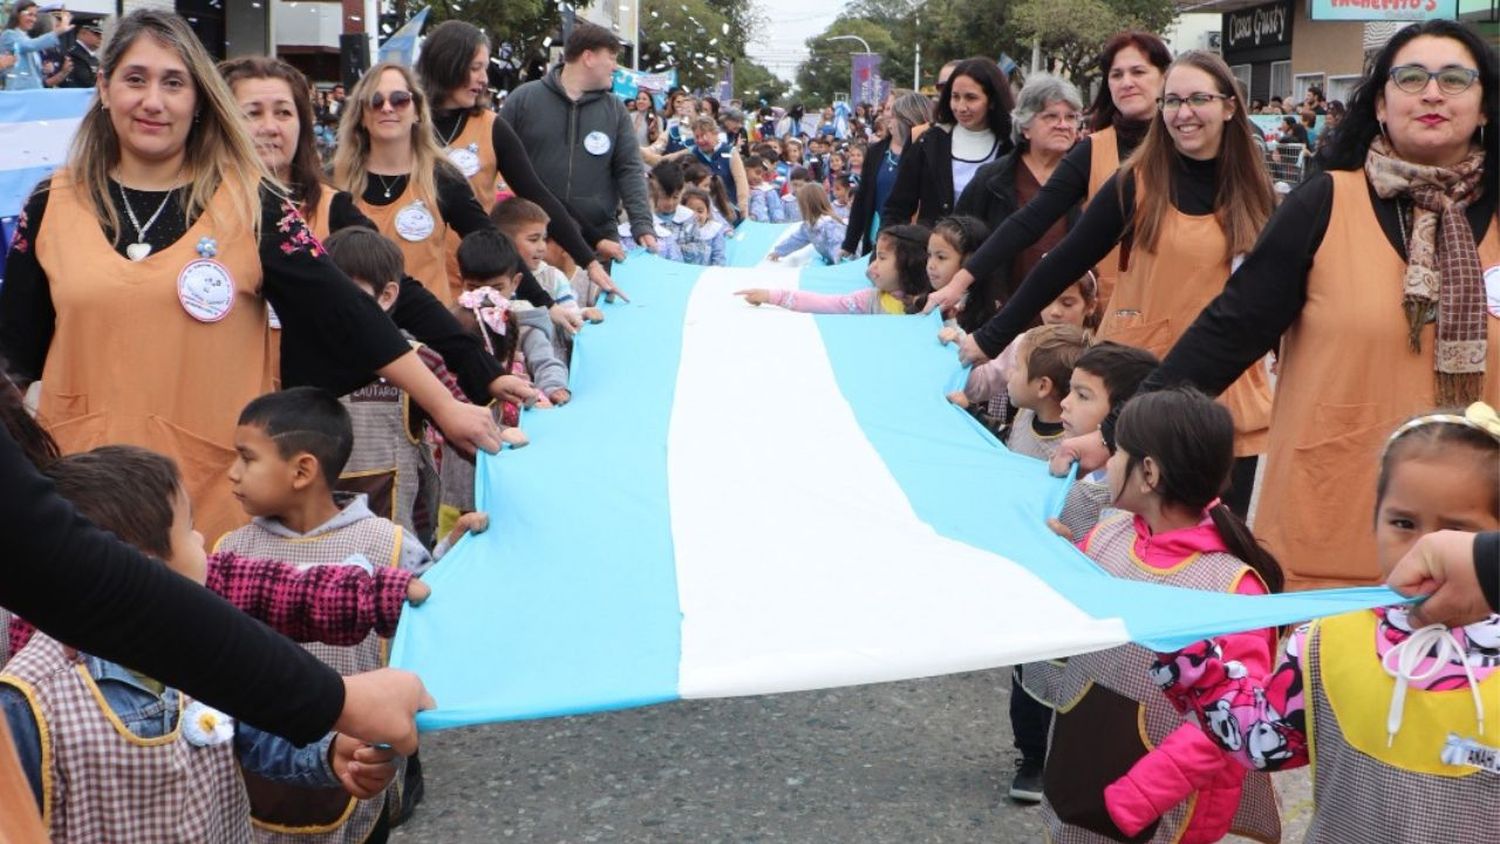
[1134,403,1500,844]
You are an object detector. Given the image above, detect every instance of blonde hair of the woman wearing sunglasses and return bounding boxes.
[333,61,447,211]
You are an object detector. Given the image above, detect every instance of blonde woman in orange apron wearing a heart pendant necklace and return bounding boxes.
[0,12,498,537]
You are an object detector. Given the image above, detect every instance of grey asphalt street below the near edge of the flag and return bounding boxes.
[392,670,1311,844]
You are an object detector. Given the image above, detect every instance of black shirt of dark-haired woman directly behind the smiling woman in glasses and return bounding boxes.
[963,124,1146,279]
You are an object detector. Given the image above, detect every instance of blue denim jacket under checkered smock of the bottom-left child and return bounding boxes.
[0,654,339,805]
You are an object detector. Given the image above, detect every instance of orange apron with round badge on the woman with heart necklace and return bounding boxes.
[36,171,272,543]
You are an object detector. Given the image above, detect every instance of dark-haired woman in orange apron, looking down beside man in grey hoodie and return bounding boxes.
[416,21,626,302]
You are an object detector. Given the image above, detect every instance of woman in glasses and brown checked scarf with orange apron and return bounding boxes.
[1122,21,1500,589]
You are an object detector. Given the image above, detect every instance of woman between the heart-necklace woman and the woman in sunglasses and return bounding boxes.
[219,55,534,405]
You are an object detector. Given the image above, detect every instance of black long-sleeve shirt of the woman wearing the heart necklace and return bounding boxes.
[0,181,411,396]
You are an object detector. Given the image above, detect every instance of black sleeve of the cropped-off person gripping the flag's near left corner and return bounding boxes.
[0,425,344,744]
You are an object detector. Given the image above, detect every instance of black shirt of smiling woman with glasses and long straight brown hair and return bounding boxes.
[974,156,1218,357]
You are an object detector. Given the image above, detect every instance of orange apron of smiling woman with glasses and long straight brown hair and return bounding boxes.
[1100,183,1271,457]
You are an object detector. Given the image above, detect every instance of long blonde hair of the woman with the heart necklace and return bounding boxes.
[66,9,270,243]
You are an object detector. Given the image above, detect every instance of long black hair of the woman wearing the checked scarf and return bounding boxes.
[1319,19,1500,173]
